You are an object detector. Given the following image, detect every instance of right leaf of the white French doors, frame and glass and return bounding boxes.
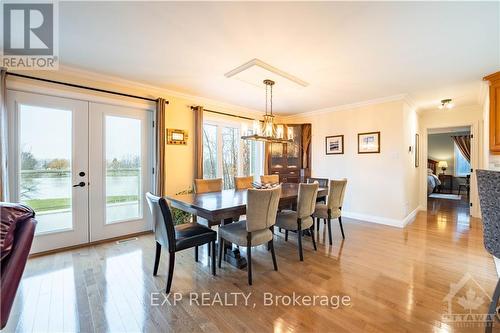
[89,103,153,241]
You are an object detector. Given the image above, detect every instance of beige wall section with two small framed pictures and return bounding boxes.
[280,100,418,227]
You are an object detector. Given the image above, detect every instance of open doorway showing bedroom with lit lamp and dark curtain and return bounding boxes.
[427,126,472,217]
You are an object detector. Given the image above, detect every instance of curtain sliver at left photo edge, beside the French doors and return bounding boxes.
[0,69,9,201]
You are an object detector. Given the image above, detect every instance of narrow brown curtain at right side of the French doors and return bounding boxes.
[155,98,167,197]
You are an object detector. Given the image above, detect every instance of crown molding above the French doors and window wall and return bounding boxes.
[53,65,264,117]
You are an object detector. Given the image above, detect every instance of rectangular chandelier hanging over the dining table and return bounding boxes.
[241,80,293,143]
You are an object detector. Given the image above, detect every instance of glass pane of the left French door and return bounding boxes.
[18,104,73,234]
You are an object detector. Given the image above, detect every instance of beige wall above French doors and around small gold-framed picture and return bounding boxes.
[7,69,262,194]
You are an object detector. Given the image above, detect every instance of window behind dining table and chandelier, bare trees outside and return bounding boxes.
[203,120,264,189]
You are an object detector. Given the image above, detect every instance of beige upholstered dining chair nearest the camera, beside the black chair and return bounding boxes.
[219,186,281,285]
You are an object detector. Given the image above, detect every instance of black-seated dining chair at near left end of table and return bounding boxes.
[146,192,217,294]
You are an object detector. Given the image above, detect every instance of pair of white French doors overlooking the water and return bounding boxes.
[7,90,152,253]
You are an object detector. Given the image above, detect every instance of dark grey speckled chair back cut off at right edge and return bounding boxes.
[476,170,500,258]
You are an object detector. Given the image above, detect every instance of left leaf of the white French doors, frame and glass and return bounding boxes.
[7,90,89,253]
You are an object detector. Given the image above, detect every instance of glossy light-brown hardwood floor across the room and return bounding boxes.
[4,200,497,332]
